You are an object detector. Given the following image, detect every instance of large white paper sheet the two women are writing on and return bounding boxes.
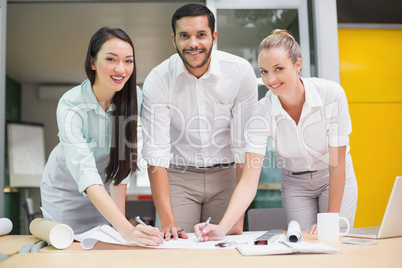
[74,225,265,249]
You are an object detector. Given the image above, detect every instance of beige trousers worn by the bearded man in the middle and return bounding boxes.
[156,165,236,233]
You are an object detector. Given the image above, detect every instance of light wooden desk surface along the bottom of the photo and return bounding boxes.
[0,232,402,268]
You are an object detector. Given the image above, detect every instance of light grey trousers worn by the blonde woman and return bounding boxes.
[282,166,357,230]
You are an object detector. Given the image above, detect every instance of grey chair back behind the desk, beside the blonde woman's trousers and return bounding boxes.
[247,208,287,231]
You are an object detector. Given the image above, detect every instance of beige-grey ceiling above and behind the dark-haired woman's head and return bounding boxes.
[6,1,203,85]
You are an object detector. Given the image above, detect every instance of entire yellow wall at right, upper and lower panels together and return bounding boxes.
[338,29,402,227]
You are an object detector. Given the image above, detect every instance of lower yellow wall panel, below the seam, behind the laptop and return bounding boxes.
[349,103,402,227]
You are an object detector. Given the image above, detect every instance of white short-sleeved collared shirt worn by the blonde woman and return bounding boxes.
[246,78,352,172]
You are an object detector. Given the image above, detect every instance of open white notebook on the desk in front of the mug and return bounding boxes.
[236,235,340,256]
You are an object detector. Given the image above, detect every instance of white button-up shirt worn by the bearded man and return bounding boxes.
[141,50,257,168]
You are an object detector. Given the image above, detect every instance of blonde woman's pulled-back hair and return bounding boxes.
[258,29,302,64]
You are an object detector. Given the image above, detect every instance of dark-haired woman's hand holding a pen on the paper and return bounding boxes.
[123,224,163,246]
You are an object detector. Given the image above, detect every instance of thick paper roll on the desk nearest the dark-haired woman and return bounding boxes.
[29,218,74,249]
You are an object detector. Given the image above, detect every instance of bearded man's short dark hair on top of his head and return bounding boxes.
[172,4,215,35]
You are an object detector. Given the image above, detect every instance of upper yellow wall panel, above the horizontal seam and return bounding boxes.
[339,29,402,102]
